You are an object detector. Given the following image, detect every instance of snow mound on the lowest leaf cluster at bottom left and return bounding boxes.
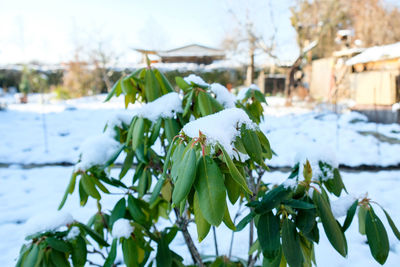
[25,212,74,235]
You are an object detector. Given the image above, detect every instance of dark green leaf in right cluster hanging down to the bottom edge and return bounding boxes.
[282,219,304,267]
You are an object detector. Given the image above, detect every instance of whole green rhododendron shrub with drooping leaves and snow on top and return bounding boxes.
[17,66,400,267]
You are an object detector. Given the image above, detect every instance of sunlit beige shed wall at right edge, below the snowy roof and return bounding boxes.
[349,70,399,105]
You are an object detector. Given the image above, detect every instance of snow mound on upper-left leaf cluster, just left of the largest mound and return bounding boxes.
[136,92,183,122]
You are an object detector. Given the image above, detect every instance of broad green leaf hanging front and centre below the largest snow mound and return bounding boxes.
[194,156,226,226]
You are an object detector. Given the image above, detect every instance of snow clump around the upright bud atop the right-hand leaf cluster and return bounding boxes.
[293,146,339,180]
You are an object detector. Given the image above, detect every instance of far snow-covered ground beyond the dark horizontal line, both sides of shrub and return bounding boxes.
[0,95,400,166]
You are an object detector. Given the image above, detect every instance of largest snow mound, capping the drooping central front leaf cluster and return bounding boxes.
[182,108,256,157]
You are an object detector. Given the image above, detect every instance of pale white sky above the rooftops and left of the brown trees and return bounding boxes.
[0,0,298,64]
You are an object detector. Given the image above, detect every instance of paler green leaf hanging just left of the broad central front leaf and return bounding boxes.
[172,148,196,206]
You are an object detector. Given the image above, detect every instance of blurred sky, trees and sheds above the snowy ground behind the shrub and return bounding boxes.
[0,0,400,122]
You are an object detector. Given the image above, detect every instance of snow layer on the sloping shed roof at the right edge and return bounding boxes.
[346,42,400,66]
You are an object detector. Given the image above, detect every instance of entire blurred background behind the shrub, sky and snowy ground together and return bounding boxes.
[0,0,400,267]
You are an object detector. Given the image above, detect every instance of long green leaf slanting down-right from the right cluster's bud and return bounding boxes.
[313,190,347,257]
